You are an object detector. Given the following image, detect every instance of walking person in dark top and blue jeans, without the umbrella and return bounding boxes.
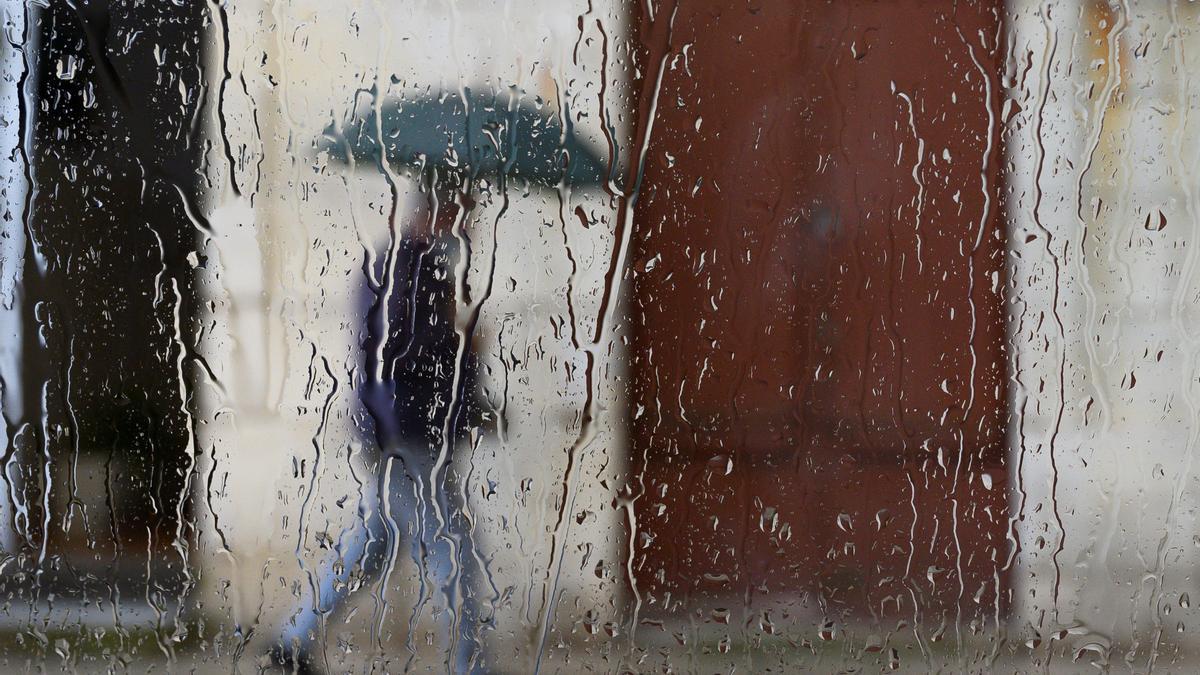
[277,181,487,673]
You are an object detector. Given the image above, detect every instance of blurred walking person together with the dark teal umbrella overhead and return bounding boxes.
[276,89,604,673]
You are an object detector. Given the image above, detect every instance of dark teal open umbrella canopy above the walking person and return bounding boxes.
[320,89,607,186]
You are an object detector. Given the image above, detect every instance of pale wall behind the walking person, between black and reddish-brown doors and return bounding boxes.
[190,0,626,659]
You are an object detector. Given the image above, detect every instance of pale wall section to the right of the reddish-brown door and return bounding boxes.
[1007,1,1200,668]
